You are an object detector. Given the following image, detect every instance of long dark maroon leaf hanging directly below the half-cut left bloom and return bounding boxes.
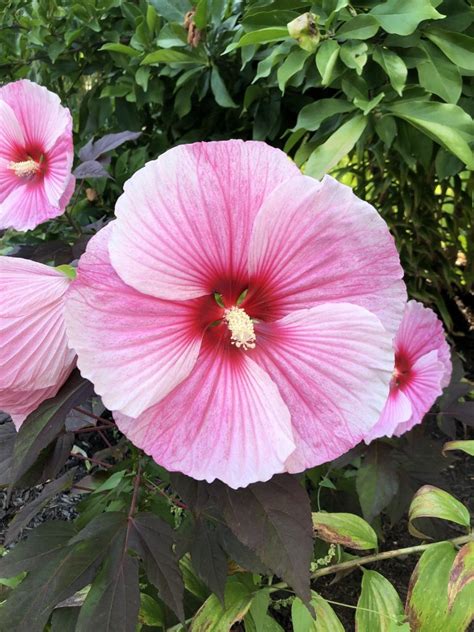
[10,369,93,485]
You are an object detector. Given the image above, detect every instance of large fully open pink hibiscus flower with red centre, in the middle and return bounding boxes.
[66,141,405,487]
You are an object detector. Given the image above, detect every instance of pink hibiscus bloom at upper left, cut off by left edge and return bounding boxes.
[0,79,75,230]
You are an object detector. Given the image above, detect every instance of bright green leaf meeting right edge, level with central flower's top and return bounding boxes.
[389,100,474,168]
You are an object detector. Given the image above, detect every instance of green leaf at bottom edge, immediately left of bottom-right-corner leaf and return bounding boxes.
[356,569,404,632]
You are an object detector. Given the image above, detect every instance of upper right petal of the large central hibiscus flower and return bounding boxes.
[249,176,406,333]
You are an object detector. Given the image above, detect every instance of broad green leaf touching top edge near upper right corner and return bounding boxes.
[369,0,446,35]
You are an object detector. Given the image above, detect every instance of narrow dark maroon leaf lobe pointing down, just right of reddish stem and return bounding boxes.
[130,512,184,621]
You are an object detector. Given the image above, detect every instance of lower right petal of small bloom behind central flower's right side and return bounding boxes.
[394,351,445,437]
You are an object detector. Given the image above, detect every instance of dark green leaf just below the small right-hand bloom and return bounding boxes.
[356,442,399,522]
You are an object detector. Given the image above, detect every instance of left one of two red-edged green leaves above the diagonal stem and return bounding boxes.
[313,512,377,551]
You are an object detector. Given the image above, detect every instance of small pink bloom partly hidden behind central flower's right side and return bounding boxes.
[365,301,452,443]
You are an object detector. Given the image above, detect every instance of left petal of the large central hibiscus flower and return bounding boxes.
[66,222,203,416]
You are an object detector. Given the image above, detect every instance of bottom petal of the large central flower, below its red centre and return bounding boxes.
[114,346,295,488]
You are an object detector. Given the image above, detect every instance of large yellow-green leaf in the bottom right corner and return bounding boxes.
[405,542,474,632]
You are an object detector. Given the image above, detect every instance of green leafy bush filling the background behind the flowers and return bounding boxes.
[0,0,474,327]
